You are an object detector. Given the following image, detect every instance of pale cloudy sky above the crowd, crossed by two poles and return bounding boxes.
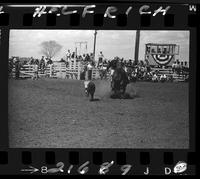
[9,30,190,61]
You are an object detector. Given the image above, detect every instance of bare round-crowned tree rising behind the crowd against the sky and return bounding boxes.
[41,40,62,59]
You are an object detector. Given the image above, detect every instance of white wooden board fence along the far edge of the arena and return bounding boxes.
[12,59,186,81]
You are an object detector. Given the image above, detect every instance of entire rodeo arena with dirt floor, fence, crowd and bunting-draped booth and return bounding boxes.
[8,31,189,148]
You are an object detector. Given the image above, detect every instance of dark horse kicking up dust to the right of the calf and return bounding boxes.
[108,59,129,98]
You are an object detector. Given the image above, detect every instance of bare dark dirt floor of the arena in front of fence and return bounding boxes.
[8,79,189,149]
